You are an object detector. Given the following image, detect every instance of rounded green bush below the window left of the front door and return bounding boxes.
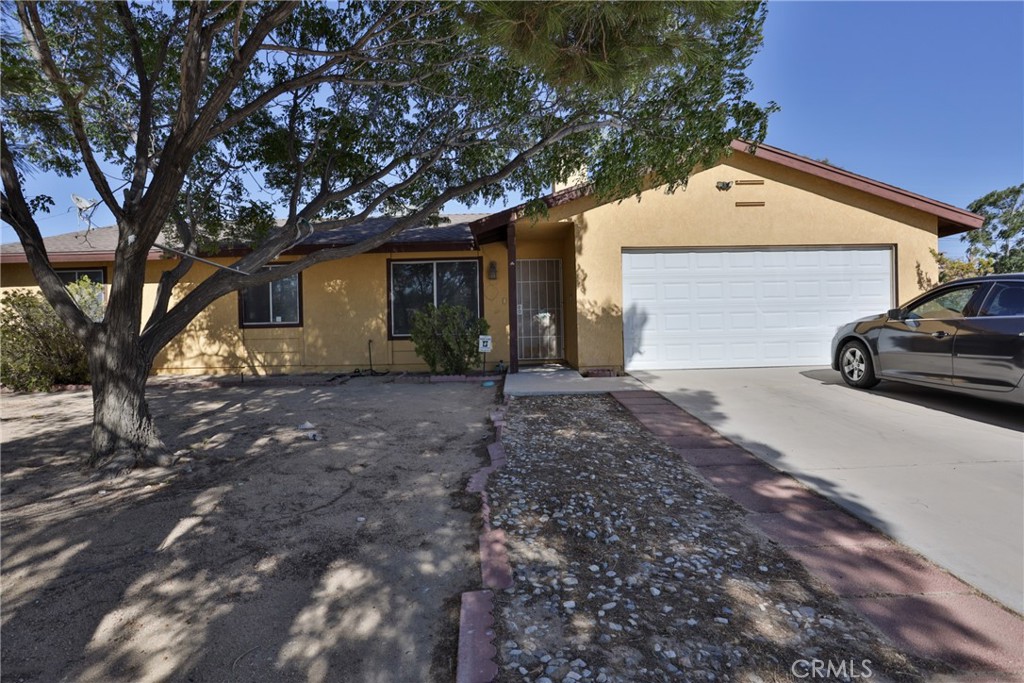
[412,303,490,375]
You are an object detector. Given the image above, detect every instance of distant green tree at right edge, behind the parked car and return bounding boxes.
[961,184,1024,272]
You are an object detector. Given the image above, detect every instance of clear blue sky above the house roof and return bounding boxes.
[3,1,1024,255]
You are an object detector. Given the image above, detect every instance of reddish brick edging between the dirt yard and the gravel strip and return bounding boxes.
[456,405,512,683]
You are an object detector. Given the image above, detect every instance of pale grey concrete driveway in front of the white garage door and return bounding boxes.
[633,368,1024,612]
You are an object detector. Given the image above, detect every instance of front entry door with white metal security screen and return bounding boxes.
[516,258,563,361]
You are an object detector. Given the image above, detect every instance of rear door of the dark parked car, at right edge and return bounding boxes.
[952,281,1024,391]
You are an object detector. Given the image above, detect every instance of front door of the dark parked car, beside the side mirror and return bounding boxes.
[878,283,985,384]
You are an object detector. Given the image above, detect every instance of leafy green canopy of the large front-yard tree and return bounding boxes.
[0,0,774,249]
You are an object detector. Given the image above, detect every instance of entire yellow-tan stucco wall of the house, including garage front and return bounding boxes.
[0,154,938,374]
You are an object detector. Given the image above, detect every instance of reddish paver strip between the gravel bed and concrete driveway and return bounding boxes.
[612,391,1024,682]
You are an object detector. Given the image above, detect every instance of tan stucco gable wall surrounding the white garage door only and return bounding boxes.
[536,155,938,371]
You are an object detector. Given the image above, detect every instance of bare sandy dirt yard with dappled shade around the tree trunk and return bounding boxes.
[0,377,496,682]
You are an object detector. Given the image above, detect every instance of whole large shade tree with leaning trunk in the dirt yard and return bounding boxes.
[0,0,773,464]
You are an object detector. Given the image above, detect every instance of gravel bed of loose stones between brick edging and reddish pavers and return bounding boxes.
[487,396,936,683]
